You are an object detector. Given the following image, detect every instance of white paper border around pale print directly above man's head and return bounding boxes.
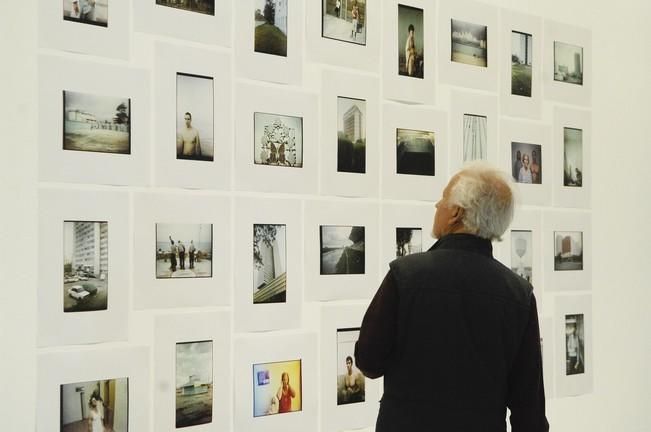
[449,90,499,172]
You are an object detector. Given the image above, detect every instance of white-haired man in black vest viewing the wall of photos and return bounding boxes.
[355,162,549,432]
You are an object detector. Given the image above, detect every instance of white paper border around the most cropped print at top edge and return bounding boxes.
[38,0,131,60]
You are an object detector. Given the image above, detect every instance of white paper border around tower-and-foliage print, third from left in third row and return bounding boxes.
[234,197,304,332]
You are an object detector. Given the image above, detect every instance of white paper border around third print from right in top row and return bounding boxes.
[438,0,501,91]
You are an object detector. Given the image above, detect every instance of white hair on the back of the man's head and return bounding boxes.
[449,161,515,240]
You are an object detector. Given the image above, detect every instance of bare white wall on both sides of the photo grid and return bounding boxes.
[0,0,651,432]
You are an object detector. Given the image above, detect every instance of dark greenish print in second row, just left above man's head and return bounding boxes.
[396,129,434,176]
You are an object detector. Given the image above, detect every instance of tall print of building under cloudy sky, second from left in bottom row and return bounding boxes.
[176,340,213,428]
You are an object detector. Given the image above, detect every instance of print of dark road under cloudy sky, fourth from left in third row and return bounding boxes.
[320,225,365,275]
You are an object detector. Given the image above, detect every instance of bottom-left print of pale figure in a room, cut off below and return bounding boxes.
[60,378,129,432]
